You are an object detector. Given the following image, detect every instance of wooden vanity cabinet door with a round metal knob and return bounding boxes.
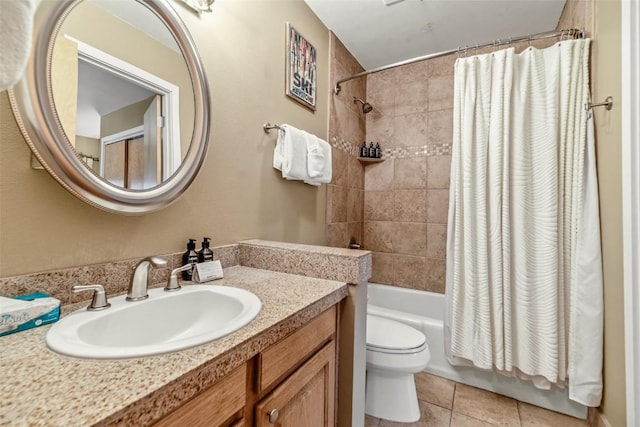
[255,341,336,427]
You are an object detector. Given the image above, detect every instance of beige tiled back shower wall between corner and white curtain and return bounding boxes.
[363,56,455,292]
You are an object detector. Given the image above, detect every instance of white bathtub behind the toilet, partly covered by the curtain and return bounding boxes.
[367,283,587,419]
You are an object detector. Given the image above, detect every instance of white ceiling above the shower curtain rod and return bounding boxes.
[304,0,565,70]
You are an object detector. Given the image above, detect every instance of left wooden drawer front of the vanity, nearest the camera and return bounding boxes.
[155,365,247,427]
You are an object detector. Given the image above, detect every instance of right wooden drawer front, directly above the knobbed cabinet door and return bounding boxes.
[258,306,336,393]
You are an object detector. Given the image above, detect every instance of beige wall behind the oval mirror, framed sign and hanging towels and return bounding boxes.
[0,0,330,278]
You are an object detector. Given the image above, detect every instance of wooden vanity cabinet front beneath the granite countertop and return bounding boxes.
[156,306,338,427]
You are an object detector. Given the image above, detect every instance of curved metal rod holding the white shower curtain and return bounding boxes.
[334,28,586,95]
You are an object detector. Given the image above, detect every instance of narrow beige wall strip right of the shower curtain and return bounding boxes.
[591,0,626,427]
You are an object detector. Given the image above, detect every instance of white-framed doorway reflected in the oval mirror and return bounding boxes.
[62,38,182,189]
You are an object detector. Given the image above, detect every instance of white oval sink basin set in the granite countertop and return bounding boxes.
[46,285,262,359]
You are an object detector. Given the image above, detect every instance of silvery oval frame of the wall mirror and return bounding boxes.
[9,0,210,215]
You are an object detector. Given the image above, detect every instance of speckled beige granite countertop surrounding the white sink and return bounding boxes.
[0,266,348,426]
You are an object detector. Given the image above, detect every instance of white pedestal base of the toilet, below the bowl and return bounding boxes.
[365,369,420,423]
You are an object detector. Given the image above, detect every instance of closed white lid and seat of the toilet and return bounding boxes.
[367,314,427,353]
